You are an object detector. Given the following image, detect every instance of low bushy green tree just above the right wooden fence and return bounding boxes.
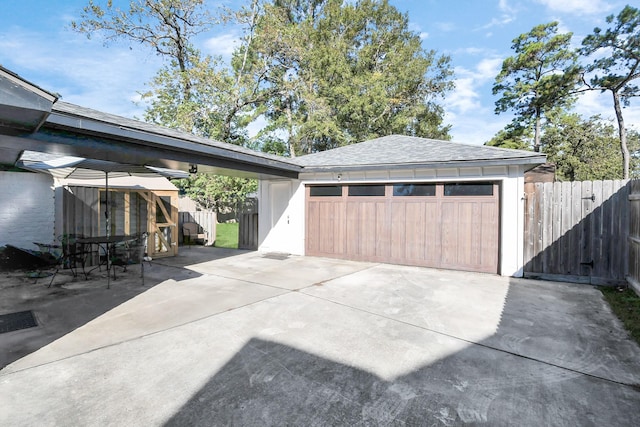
[541,114,623,181]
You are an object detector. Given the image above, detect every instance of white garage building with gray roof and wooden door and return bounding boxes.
[259,135,545,276]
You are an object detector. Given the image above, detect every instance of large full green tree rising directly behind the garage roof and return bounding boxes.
[248,0,453,156]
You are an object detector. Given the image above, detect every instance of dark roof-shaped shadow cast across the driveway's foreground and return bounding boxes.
[165,279,640,426]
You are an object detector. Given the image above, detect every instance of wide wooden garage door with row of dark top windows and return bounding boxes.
[306,182,500,273]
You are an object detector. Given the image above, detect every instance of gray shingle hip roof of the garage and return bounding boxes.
[295,135,545,171]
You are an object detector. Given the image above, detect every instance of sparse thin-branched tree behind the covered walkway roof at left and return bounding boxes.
[72,0,257,210]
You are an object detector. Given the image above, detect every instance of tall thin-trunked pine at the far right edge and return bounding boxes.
[581,6,640,179]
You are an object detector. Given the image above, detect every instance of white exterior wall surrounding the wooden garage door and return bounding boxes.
[258,166,524,277]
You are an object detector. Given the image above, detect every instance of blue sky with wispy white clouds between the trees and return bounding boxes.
[0,0,640,144]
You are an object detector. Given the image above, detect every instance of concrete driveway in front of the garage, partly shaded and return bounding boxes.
[0,247,640,426]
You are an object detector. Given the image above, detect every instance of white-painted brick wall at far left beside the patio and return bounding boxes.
[0,172,55,249]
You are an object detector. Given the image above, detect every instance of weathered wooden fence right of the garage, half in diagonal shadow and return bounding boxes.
[524,180,640,284]
